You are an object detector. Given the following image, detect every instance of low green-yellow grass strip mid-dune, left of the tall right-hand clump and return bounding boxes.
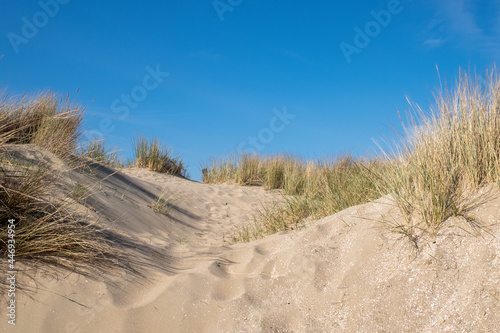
[204,154,385,241]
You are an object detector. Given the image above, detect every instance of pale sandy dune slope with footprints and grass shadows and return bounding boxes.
[0,147,500,332]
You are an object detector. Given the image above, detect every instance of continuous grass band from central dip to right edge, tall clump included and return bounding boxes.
[203,69,500,247]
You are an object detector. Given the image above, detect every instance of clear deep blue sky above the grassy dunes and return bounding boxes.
[0,0,500,179]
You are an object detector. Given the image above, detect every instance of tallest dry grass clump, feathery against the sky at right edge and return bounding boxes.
[378,70,500,239]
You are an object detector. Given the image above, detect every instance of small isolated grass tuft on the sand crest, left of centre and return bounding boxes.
[134,135,186,176]
